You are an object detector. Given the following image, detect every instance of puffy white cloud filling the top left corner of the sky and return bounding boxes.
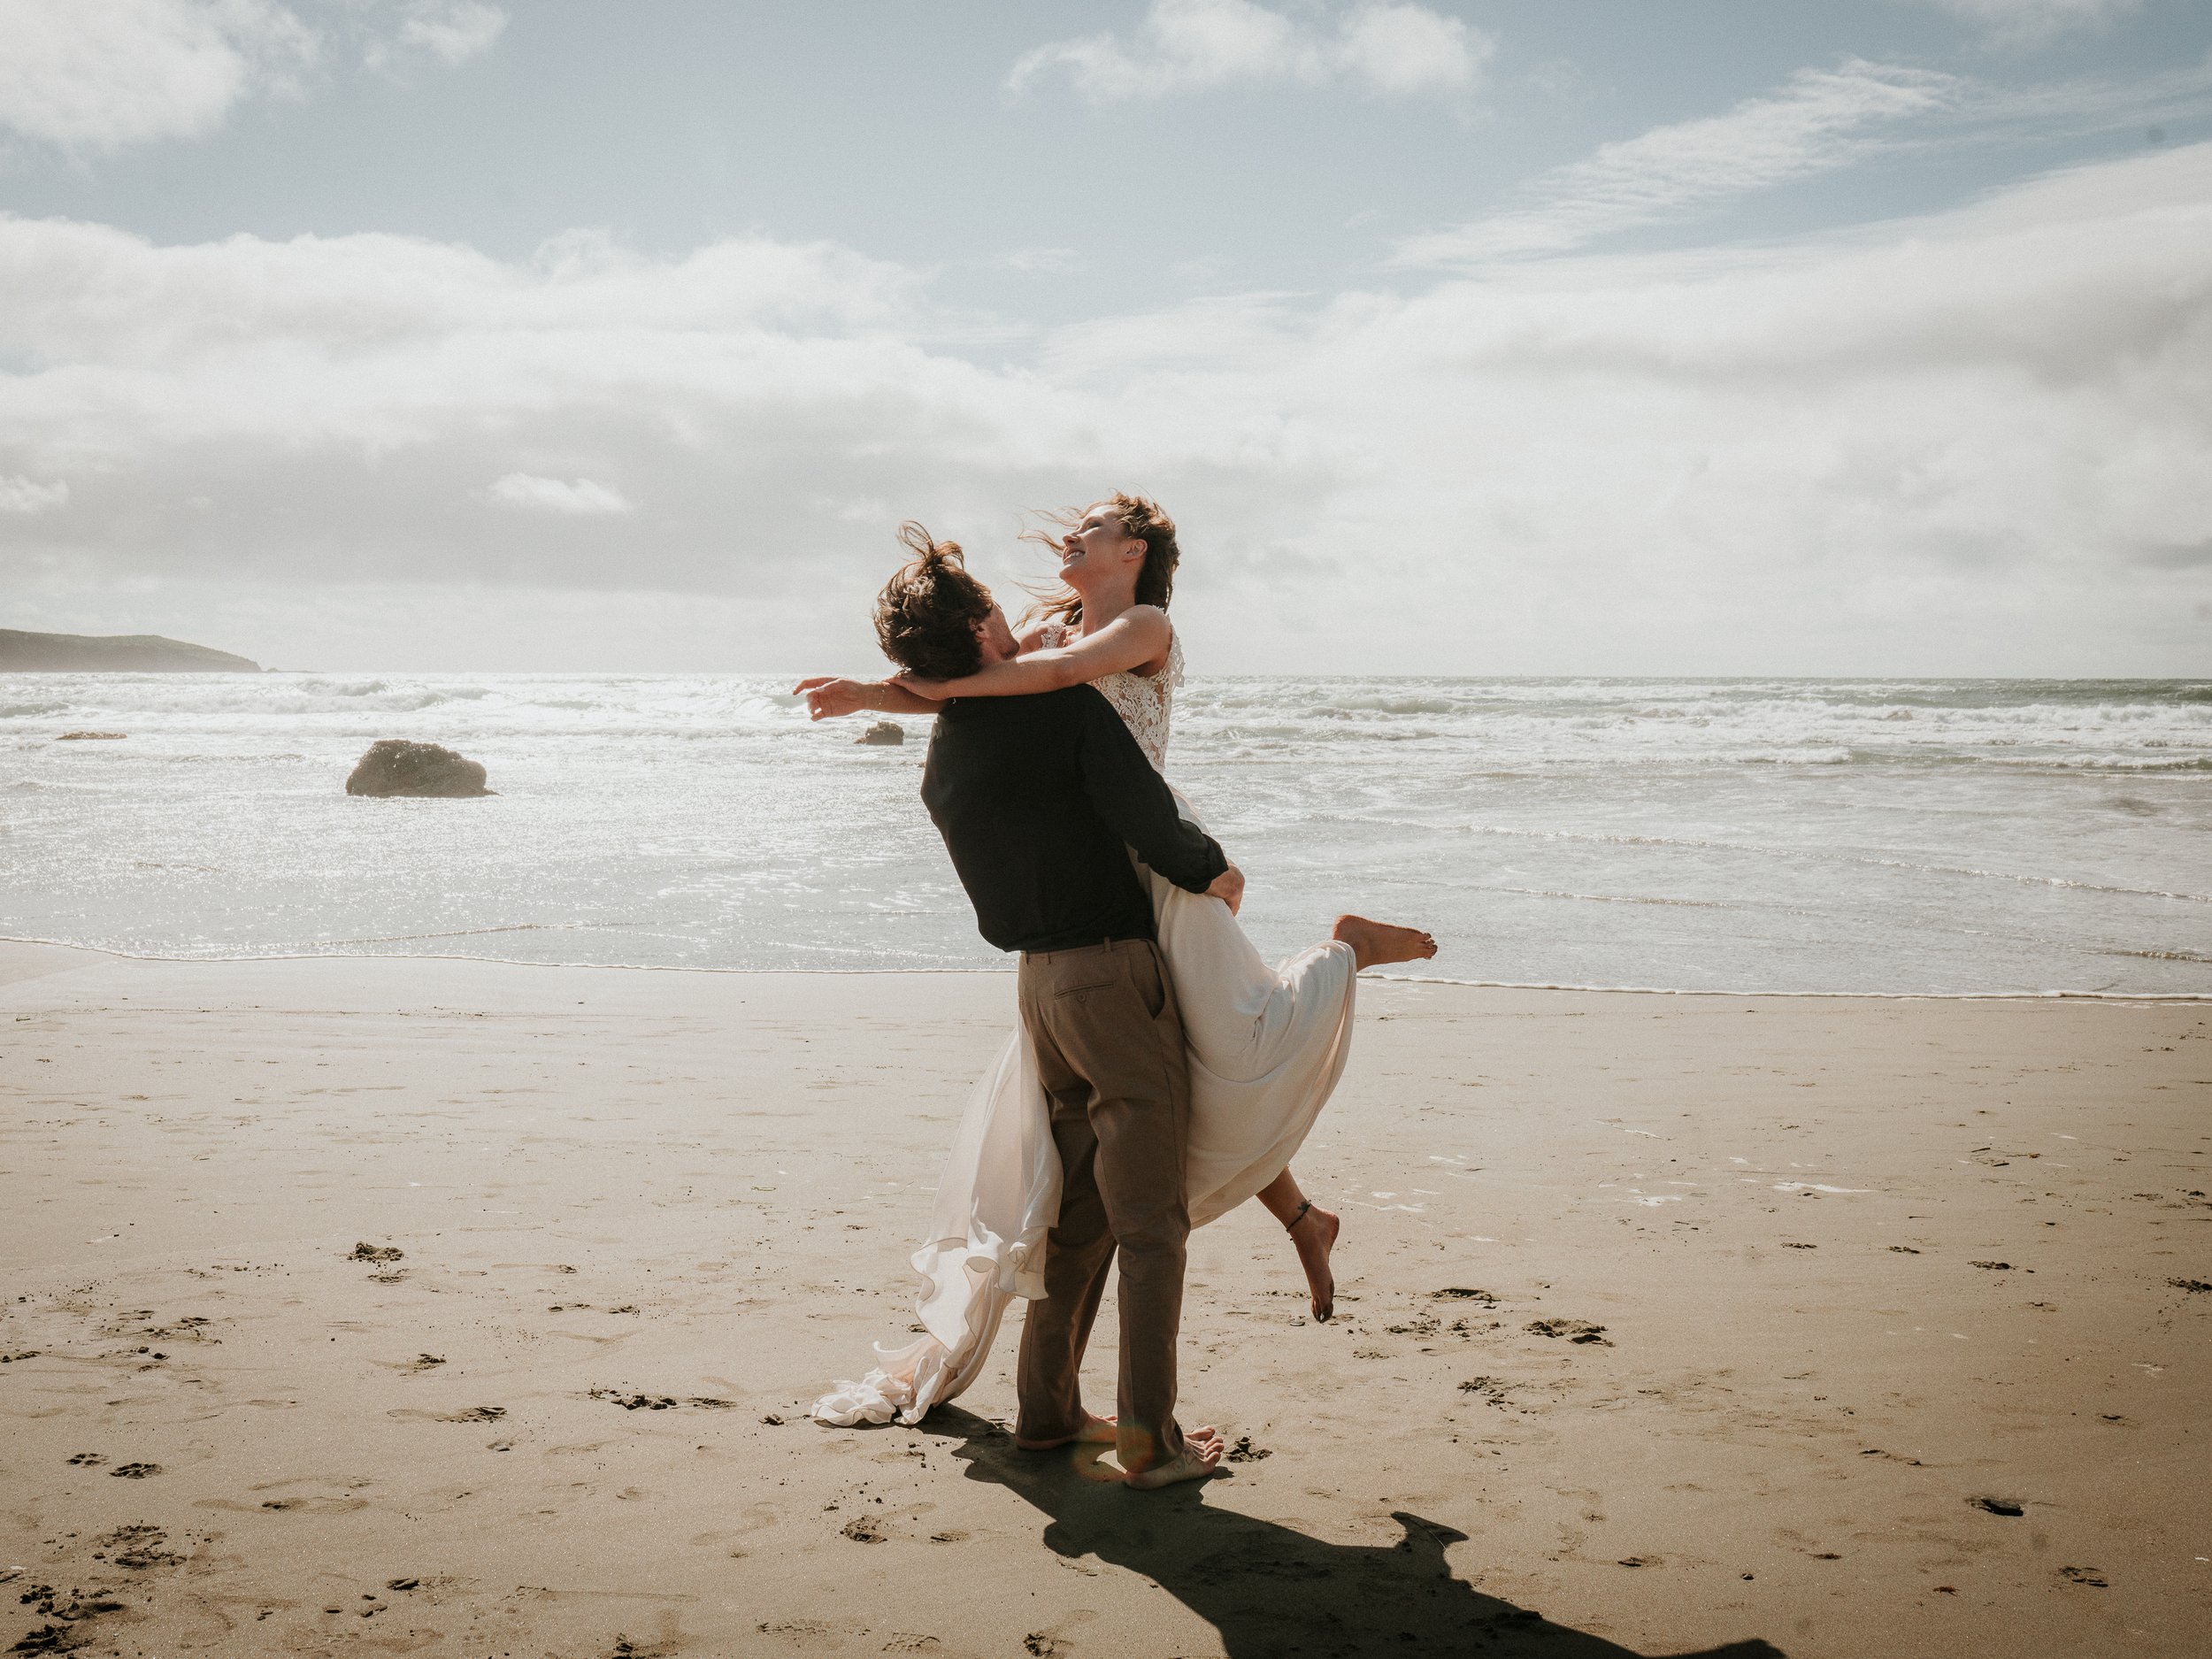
[0,0,507,153]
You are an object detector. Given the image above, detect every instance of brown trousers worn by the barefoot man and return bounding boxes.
[1018,941,1190,1473]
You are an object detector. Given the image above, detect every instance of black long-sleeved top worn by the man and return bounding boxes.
[923,686,1228,951]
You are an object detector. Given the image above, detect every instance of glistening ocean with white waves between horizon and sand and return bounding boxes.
[0,675,2212,995]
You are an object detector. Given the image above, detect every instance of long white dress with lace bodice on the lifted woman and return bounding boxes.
[814,635,1356,1427]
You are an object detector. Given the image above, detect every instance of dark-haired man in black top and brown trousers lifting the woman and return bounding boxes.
[801,525,1243,1489]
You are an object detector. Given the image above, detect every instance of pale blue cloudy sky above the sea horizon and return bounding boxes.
[0,0,2212,677]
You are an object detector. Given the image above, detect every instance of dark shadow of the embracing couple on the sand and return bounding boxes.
[923,1407,1783,1659]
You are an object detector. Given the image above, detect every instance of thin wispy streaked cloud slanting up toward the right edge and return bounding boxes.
[1392,58,2212,268]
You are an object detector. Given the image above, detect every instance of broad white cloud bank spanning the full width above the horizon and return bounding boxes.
[0,144,2212,675]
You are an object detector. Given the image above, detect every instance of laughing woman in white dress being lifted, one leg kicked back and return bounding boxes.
[799,494,1436,1423]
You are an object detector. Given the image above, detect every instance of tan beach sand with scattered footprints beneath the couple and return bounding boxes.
[0,947,2212,1659]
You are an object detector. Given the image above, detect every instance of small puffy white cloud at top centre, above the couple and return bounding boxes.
[1007,0,1495,104]
